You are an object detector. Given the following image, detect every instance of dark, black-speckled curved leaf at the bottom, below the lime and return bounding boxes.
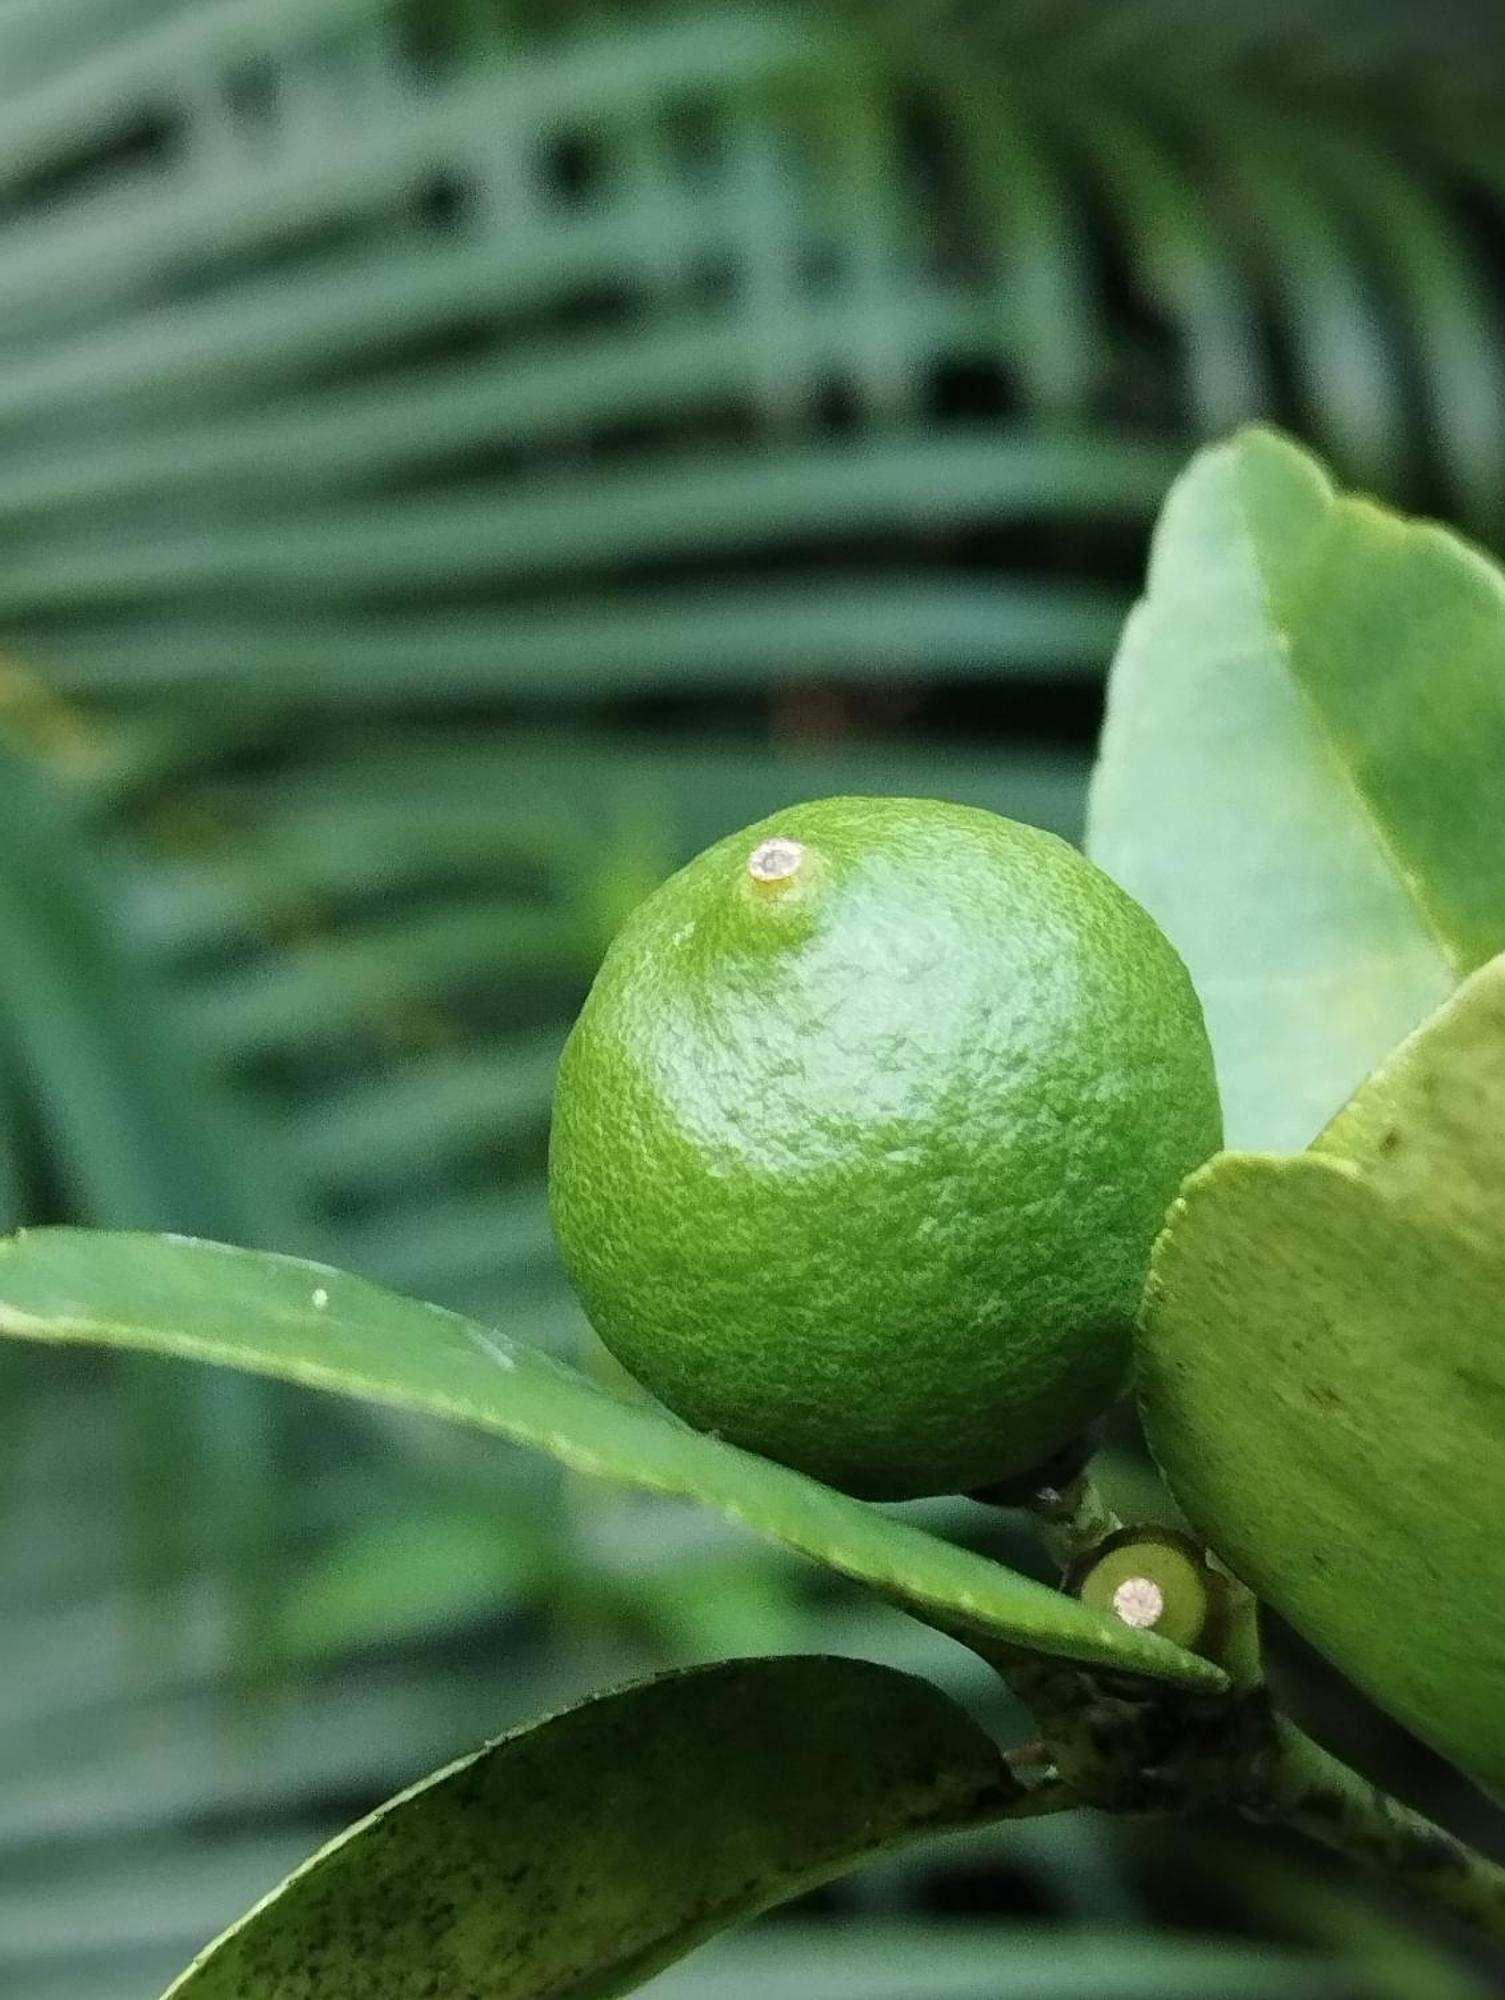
[170,1658,1039,2000]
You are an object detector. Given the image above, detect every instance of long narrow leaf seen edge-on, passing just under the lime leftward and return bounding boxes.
[0,1230,1221,1688]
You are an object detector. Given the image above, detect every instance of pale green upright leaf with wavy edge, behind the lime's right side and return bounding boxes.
[1089,430,1505,1150]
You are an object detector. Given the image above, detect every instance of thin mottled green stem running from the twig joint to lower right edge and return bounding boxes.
[1257,1718,1505,1944]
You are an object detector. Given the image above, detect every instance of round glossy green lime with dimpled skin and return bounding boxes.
[550,798,1221,1498]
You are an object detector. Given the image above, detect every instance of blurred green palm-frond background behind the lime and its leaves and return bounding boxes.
[0,0,1505,2000]
